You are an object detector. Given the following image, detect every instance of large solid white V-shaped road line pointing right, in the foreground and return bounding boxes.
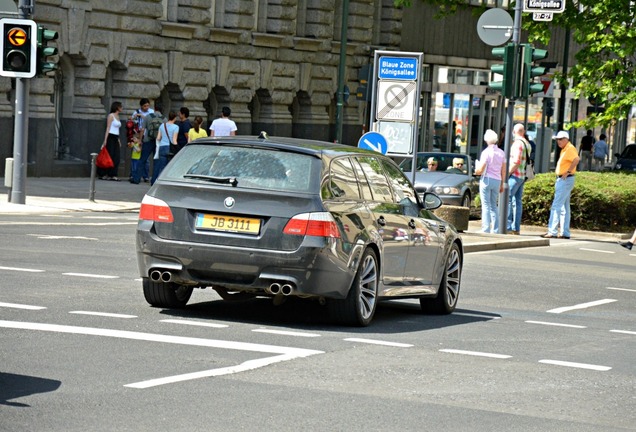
[0,320,324,388]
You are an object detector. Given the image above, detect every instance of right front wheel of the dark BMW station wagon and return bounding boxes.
[420,244,462,315]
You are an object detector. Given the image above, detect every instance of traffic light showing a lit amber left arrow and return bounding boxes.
[0,18,37,78]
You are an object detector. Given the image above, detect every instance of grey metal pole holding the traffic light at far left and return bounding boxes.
[9,0,35,204]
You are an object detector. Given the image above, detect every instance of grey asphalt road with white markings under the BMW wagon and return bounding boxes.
[0,213,636,432]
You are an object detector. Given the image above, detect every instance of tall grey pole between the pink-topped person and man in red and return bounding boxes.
[497,1,523,234]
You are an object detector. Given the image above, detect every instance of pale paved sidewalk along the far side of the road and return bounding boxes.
[0,178,625,253]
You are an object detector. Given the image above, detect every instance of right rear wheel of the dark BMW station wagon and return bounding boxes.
[329,249,380,327]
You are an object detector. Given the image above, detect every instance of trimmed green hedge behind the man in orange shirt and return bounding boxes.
[522,171,636,233]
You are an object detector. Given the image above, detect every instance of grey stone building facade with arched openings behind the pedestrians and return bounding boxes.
[0,0,403,176]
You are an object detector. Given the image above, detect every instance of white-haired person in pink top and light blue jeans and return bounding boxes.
[475,129,506,233]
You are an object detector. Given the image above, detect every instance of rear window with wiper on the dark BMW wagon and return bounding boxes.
[160,144,320,193]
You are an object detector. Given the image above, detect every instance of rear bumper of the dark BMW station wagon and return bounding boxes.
[137,230,357,299]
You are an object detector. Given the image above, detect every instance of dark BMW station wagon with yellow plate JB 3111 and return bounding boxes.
[136,135,463,326]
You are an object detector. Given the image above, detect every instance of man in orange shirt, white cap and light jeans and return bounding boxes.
[541,131,580,239]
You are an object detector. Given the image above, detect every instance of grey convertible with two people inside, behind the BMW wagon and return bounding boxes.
[400,152,479,208]
